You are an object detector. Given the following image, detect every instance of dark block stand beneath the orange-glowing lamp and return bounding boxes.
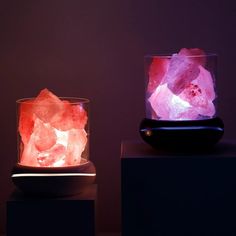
[7,184,97,236]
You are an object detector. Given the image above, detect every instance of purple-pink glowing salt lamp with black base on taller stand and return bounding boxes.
[139,48,224,150]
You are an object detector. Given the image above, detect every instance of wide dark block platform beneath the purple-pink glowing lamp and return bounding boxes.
[121,141,236,236]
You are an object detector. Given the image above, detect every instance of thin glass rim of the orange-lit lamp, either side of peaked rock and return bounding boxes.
[16,97,90,104]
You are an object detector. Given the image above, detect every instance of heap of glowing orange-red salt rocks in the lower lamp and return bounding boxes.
[19,89,88,167]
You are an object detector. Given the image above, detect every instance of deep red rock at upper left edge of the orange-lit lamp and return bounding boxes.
[18,100,35,144]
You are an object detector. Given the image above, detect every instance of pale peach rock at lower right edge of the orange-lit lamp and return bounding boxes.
[66,129,87,165]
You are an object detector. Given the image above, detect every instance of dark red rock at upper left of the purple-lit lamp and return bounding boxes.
[147,57,169,93]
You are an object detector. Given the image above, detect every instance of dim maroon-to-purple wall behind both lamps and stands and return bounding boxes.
[0,0,236,233]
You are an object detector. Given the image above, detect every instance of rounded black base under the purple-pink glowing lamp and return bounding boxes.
[139,117,224,151]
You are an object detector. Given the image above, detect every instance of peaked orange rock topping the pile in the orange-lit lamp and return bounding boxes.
[33,89,64,123]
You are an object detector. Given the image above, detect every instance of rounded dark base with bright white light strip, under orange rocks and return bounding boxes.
[11,161,96,197]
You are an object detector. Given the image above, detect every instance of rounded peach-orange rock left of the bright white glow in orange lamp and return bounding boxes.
[34,119,57,152]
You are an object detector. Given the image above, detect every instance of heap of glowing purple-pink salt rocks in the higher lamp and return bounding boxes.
[147,48,216,120]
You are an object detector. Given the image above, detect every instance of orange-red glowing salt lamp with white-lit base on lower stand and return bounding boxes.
[12,89,96,195]
